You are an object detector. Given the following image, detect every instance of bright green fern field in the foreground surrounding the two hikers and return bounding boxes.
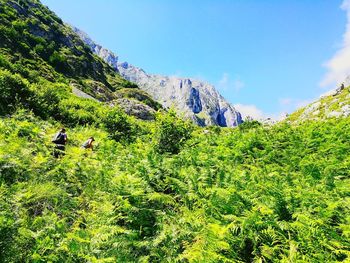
[0,111,350,262]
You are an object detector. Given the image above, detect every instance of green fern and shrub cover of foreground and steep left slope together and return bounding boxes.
[0,0,350,263]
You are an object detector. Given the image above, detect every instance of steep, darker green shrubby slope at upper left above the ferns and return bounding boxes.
[0,0,159,118]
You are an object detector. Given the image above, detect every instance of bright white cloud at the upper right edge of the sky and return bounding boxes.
[320,0,350,87]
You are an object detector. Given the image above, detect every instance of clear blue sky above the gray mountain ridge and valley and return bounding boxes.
[42,0,350,119]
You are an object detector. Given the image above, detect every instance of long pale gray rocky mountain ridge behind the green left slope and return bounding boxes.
[73,28,243,127]
